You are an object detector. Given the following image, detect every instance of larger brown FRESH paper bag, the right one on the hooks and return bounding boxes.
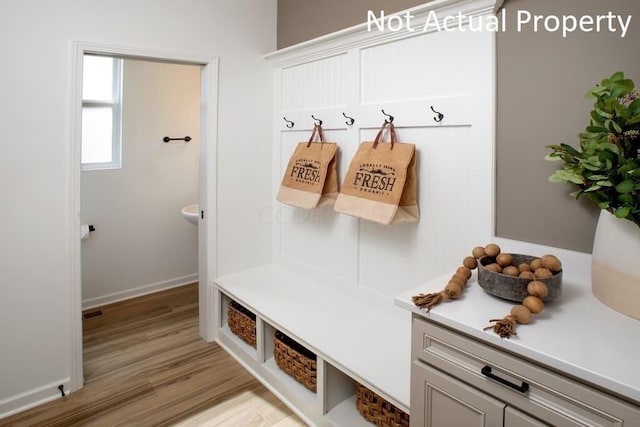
[333,120,420,224]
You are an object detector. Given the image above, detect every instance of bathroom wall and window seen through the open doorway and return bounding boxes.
[80,55,201,310]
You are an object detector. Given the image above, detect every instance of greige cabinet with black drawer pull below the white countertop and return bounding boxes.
[411,314,640,427]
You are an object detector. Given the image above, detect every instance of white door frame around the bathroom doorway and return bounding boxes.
[68,41,219,392]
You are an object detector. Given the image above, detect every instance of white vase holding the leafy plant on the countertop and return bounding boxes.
[591,210,640,319]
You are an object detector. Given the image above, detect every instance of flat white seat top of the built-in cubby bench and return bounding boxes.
[216,265,411,412]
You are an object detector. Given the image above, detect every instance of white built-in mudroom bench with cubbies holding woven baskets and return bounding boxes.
[216,264,411,426]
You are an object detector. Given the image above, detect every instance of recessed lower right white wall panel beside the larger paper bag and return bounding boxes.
[358,126,482,295]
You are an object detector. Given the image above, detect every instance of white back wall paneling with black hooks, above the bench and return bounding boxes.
[274,26,493,299]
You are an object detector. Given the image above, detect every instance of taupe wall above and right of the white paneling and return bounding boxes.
[278,0,640,252]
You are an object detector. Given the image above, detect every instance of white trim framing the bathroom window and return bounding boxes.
[81,53,124,170]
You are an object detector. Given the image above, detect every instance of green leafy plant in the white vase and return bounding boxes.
[546,71,640,227]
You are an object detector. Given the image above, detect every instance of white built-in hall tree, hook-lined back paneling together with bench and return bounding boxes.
[216,0,501,426]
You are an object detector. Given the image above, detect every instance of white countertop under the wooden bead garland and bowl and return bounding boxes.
[395,271,640,403]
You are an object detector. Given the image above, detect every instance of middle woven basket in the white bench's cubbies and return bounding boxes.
[273,331,317,393]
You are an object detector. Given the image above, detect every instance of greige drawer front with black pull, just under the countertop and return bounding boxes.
[412,316,640,426]
